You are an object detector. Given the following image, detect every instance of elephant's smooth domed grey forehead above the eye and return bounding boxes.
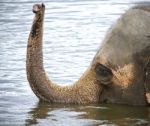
[96,9,150,68]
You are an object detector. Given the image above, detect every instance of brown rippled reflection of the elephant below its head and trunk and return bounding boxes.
[26,103,150,126]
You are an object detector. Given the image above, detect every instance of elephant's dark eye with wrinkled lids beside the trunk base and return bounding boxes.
[95,64,113,85]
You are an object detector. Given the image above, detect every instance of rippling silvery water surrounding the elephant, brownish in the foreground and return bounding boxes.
[0,0,150,126]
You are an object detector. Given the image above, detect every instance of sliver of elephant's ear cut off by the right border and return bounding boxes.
[144,58,150,104]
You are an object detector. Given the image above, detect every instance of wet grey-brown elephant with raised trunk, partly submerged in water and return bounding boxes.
[26,3,150,105]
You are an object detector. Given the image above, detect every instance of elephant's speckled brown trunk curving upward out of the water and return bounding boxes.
[26,4,102,103]
